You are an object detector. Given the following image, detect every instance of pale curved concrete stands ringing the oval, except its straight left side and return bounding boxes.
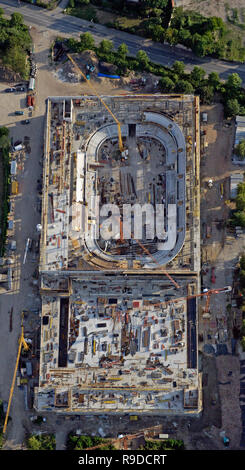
[83,112,186,268]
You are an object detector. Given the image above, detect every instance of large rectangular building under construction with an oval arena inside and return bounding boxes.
[35,94,202,414]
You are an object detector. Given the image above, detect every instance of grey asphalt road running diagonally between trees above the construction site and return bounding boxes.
[0,0,245,83]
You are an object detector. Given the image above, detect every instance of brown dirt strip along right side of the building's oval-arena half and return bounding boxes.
[200,104,236,263]
